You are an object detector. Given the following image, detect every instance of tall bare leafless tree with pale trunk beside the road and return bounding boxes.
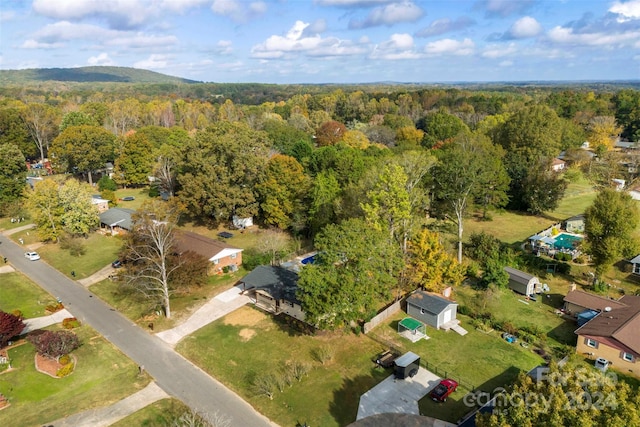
[125,200,182,318]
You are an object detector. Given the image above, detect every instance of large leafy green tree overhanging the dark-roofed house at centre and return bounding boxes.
[297,218,402,329]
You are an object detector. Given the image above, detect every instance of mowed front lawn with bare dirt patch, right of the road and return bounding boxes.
[177,307,389,427]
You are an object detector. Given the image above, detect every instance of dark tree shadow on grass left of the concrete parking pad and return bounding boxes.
[329,368,390,426]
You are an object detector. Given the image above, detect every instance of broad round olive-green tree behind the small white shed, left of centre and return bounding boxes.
[178,121,270,222]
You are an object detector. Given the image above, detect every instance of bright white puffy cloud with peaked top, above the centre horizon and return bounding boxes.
[251,21,364,59]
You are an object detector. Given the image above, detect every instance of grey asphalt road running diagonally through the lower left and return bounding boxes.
[0,235,275,427]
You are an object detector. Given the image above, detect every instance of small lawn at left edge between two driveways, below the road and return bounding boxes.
[0,273,56,319]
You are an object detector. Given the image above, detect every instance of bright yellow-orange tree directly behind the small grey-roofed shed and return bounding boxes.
[406,228,465,293]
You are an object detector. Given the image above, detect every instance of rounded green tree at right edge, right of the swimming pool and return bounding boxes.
[585,188,640,277]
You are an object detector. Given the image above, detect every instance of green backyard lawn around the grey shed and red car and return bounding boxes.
[369,312,543,422]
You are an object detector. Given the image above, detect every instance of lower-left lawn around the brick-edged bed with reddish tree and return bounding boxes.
[0,326,149,427]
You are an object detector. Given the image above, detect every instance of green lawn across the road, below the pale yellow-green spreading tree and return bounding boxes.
[37,233,122,279]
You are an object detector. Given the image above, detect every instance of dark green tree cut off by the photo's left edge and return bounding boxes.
[0,144,27,212]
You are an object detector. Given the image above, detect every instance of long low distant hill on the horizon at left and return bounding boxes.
[0,67,200,85]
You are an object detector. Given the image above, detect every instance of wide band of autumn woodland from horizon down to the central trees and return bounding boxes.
[0,89,640,327]
